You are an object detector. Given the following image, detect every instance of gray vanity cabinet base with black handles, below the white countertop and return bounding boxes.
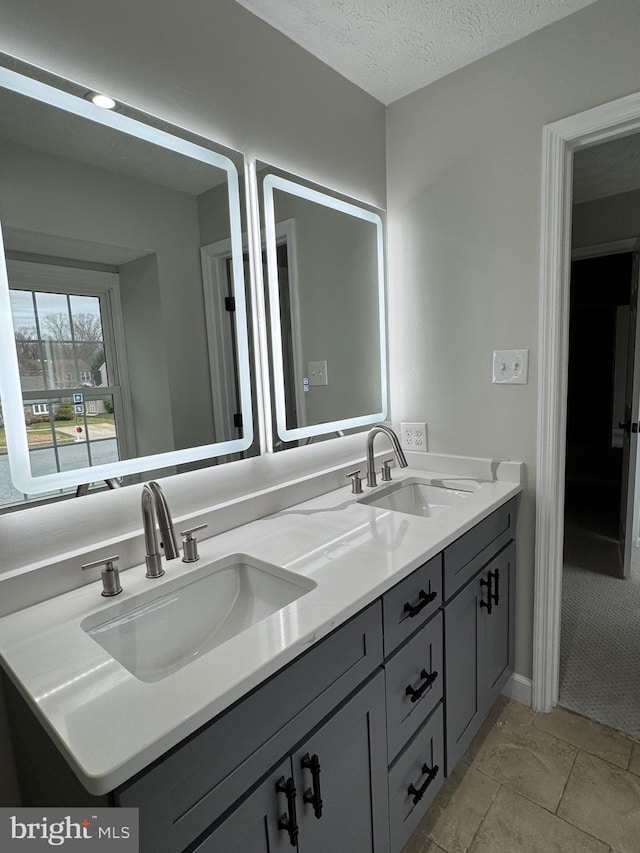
[3,492,516,853]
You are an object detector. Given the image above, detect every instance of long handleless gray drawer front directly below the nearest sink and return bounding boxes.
[115,602,382,853]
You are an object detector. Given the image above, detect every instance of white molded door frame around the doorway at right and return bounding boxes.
[532,88,640,711]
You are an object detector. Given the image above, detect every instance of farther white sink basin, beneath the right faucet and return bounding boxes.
[360,477,477,518]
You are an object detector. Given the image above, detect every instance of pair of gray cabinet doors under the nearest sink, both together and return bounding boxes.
[193,672,389,853]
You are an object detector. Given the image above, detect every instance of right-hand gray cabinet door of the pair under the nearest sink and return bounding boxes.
[293,672,389,853]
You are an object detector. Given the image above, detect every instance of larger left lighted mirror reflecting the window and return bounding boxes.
[0,62,254,507]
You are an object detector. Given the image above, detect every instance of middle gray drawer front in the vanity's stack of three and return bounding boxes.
[385,611,444,762]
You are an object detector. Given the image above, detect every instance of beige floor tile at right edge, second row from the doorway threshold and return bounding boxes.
[558,752,640,853]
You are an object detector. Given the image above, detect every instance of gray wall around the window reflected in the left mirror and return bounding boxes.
[0,136,213,454]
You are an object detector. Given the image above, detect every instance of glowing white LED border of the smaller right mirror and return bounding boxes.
[262,174,389,441]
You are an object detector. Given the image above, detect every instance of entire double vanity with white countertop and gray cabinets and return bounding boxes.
[0,462,520,853]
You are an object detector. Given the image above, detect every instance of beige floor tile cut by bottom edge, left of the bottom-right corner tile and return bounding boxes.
[469,788,609,853]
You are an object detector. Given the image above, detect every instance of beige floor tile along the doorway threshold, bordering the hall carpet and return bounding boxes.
[533,708,633,769]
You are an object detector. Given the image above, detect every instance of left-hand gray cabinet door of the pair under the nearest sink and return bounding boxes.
[193,759,297,853]
